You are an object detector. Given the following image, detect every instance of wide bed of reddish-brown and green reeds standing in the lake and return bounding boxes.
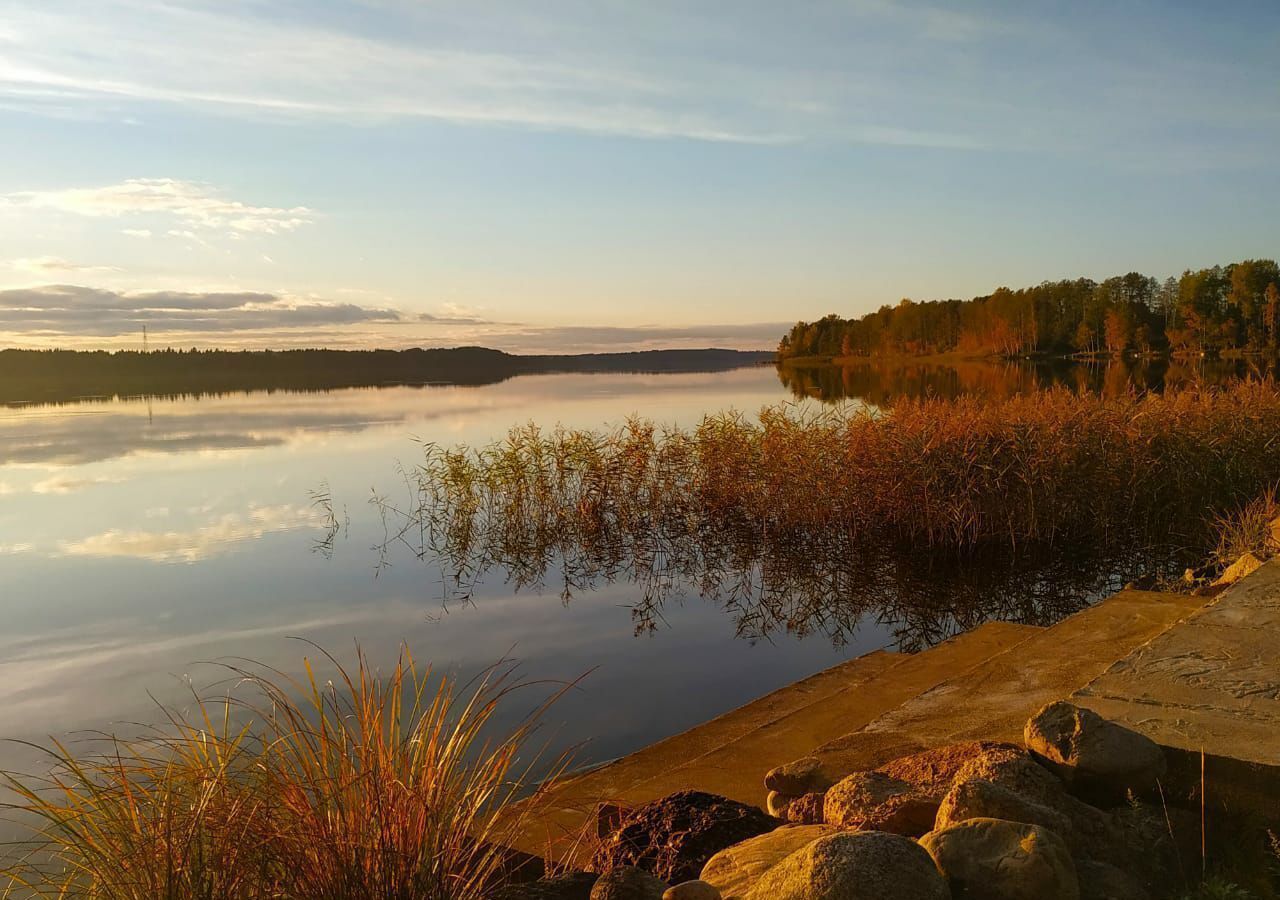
[379,380,1280,644]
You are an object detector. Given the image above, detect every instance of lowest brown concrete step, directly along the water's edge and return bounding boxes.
[518,622,1041,855]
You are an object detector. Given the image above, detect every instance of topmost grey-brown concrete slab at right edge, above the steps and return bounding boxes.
[1071,559,1280,817]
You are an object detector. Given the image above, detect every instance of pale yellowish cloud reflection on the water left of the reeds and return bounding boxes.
[59,506,320,563]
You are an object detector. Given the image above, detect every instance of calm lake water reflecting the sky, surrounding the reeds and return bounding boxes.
[0,358,1239,767]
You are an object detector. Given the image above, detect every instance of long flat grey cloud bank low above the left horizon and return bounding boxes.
[0,284,403,337]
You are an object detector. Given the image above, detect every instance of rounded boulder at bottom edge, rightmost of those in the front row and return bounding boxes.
[920,819,1080,900]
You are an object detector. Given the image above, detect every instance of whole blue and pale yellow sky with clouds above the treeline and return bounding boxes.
[0,0,1280,352]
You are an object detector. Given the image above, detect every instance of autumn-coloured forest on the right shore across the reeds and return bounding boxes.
[778,260,1280,358]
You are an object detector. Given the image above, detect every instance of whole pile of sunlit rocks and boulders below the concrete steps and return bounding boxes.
[560,703,1178,900]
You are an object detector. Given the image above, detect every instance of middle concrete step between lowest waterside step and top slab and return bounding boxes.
[793,590,1204,776]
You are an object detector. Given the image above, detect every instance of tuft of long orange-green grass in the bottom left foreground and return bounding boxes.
[0,653,570,900]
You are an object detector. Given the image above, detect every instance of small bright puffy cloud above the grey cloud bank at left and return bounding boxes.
[5,178,315,237]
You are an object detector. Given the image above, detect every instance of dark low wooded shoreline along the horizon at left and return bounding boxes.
[0,347,776,406]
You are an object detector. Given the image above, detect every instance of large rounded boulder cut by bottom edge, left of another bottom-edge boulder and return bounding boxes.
[746,831,948,900]
